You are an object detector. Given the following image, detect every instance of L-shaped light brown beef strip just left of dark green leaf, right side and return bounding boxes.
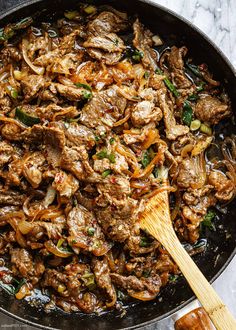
[157,88,189,140]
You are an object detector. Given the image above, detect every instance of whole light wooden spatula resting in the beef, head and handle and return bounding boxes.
[140,178,236,330]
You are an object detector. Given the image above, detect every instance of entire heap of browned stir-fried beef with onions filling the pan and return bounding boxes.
[0,4,236,313]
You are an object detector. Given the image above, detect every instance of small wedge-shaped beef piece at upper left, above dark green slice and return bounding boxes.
[21,74,45,101]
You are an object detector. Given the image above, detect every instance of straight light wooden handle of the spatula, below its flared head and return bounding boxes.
[163,230,236,330]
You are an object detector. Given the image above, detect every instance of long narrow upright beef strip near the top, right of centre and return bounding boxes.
[133,19,157,71]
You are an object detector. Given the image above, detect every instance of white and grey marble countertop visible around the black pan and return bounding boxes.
[0,0,236,330]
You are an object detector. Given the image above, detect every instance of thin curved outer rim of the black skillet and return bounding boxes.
[0,0,236,330]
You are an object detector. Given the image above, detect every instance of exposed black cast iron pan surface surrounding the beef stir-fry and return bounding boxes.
[0,0,236,330]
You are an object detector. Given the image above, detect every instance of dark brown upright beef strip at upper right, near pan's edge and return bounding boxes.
[167,46,192,88]
